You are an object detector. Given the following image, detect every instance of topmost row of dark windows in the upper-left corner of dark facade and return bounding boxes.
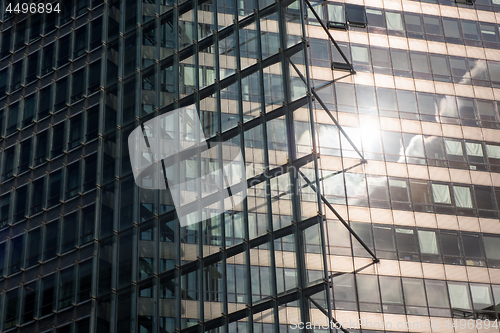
[0,0,103,47]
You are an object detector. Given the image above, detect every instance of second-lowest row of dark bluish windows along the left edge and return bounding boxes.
[0,206,95,278]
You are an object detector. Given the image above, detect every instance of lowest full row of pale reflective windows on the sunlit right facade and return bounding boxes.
[332,272,500,325]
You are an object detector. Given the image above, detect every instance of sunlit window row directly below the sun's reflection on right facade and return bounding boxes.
[320,173,500,218]
